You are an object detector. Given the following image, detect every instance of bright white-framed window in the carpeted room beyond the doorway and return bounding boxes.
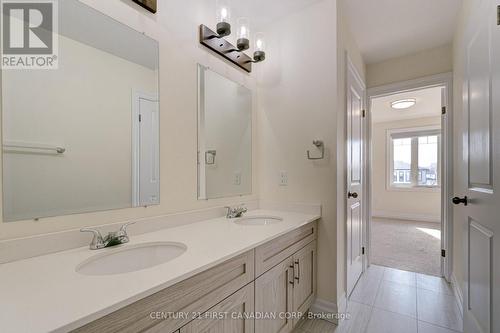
[387,127,441,188]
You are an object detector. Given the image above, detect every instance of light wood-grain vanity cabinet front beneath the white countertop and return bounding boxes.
[73,222,316,333]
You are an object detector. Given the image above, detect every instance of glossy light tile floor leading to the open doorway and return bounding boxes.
[294,265,462,333]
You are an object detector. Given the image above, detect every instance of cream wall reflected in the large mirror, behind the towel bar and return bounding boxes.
[3,36,158,220]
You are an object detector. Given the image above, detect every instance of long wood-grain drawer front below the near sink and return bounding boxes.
[73,250,255,333]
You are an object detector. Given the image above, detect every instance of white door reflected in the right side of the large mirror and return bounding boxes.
[133,94,160,206]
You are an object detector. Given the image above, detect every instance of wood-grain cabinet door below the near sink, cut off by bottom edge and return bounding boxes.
[180,283,254,333]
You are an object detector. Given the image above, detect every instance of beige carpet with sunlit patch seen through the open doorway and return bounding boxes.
[371,218,441,276]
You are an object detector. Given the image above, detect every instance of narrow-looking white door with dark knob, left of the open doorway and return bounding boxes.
[346,60,365,296]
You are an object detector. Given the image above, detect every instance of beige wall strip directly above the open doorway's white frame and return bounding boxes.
[366,45,453,88]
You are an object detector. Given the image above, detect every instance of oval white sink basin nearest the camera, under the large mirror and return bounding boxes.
[76,242,187,275]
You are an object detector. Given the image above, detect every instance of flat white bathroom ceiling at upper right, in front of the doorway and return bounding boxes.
[345,0,462,64]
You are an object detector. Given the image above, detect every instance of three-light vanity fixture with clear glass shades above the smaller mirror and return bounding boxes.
[200,0,266,73]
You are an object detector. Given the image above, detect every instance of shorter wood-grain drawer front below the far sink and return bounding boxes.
[255,222,317,276]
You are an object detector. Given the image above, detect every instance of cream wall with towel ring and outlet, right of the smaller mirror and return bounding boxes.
[257,0,364,305]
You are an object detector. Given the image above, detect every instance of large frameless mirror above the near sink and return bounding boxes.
[2,0,160,221]
